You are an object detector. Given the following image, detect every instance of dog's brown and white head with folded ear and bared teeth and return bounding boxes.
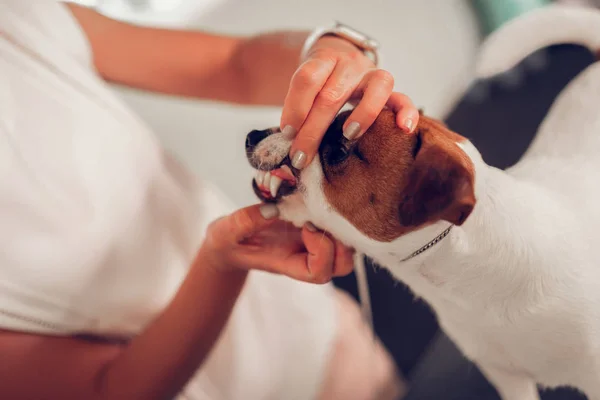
[246,110,475,245]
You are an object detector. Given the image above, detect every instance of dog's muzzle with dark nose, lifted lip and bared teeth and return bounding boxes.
[246,128,299,203]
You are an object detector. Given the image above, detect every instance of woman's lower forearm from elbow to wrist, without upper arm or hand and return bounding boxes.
[99,267,246,400]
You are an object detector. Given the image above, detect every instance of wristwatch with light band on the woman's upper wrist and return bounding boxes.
[300,22,380,66]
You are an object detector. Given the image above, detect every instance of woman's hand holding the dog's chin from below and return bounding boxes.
[198,204,353,283]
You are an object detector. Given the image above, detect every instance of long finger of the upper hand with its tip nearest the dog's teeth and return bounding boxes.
[290,64,360,169]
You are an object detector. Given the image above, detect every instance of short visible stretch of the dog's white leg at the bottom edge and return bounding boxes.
[480,366,540,400]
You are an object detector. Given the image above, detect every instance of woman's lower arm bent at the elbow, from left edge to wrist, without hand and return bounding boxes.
[0,256,246,400]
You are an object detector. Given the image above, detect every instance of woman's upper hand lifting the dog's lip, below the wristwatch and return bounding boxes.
[281,37,419,169]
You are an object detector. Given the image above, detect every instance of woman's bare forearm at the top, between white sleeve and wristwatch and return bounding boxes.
[69,5,307,105]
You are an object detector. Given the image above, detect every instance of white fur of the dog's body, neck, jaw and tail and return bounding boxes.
[264,6,600,400]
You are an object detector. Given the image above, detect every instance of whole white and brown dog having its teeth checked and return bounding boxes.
[246,6,600,400]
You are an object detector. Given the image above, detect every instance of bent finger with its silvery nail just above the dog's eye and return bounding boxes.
[343,69,394,140]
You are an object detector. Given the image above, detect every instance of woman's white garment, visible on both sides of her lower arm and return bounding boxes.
[0,0,335,400]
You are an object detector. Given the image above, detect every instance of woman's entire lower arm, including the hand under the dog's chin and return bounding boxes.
[0,205,352,400]
